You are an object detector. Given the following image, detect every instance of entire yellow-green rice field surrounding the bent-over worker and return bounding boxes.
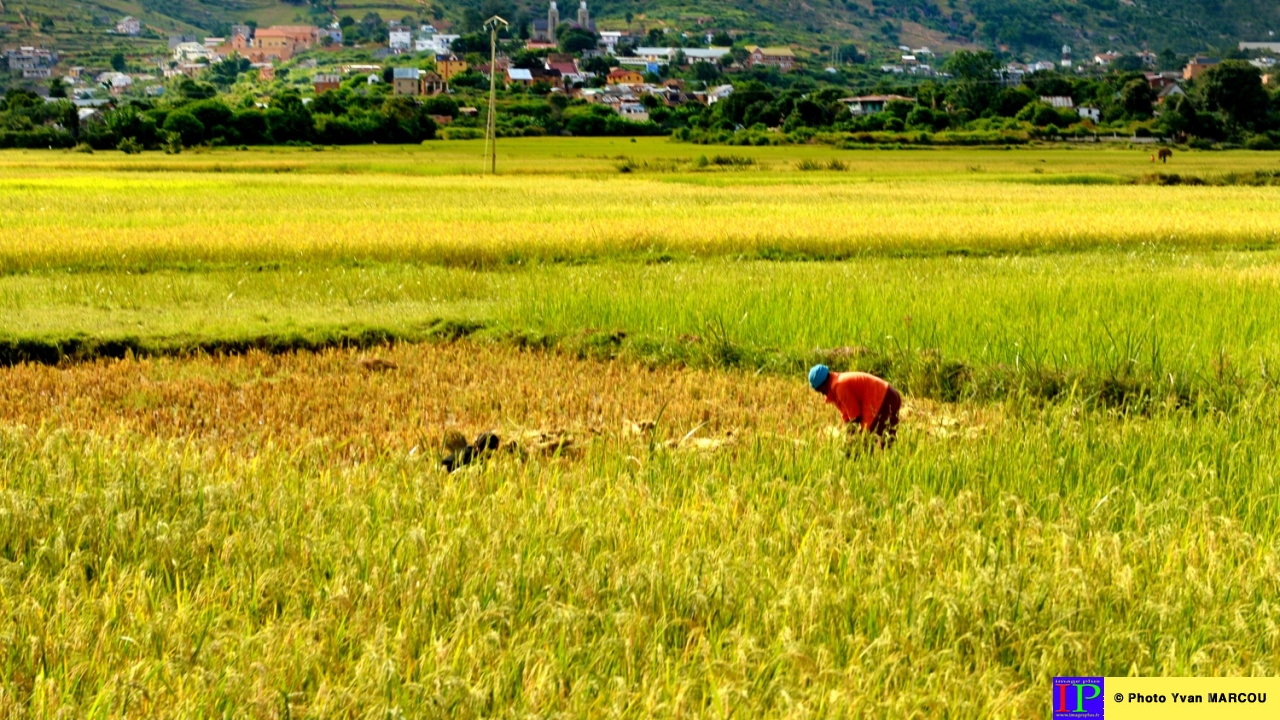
[0,140,1280,717]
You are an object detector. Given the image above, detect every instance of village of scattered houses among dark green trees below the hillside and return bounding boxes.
[5,0,1280,146]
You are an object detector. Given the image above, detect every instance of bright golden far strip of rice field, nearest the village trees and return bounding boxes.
[0,141,1280,270]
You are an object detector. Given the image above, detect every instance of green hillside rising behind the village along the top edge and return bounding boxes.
[0,0,1280,60]
